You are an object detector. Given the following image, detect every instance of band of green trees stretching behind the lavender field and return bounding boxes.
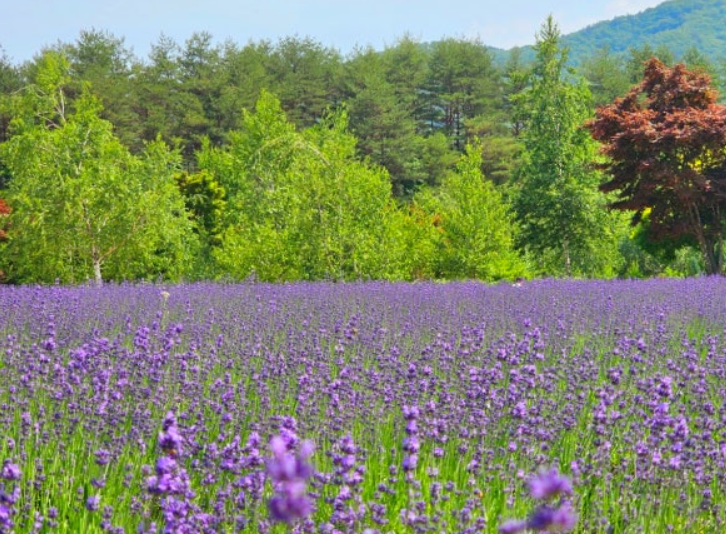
[0,18,721,283]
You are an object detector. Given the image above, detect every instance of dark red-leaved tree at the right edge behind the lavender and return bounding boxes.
[588,58,726,274]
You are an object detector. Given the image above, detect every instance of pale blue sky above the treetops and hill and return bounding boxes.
[0,0,663,62]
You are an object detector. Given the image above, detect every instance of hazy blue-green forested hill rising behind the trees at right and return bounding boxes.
[492,0,726,65]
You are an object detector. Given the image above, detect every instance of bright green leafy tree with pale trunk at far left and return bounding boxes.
[0,52,193,284]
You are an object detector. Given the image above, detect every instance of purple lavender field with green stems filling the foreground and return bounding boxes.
[0,278,726,534]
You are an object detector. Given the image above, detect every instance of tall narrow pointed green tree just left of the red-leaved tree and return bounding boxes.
[514,17,614,276]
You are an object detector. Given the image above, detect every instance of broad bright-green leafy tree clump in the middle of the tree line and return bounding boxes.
[199,93,418,280]
